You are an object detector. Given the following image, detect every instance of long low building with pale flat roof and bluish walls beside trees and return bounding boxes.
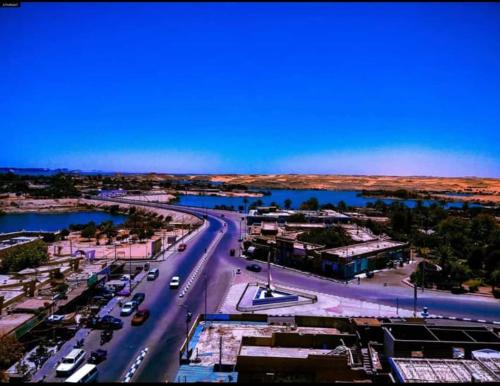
[321,240,409,280]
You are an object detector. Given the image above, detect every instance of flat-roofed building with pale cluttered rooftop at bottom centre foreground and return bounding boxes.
[177,314,369,383]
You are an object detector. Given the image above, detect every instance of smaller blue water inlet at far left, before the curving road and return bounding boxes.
[0,211,127,233]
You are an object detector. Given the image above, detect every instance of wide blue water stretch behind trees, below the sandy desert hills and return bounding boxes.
[179,189,477,210]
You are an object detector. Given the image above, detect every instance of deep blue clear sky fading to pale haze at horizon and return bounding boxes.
[0,3,500,177]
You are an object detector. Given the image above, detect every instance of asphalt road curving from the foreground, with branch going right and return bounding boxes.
[58,202,500,382]
